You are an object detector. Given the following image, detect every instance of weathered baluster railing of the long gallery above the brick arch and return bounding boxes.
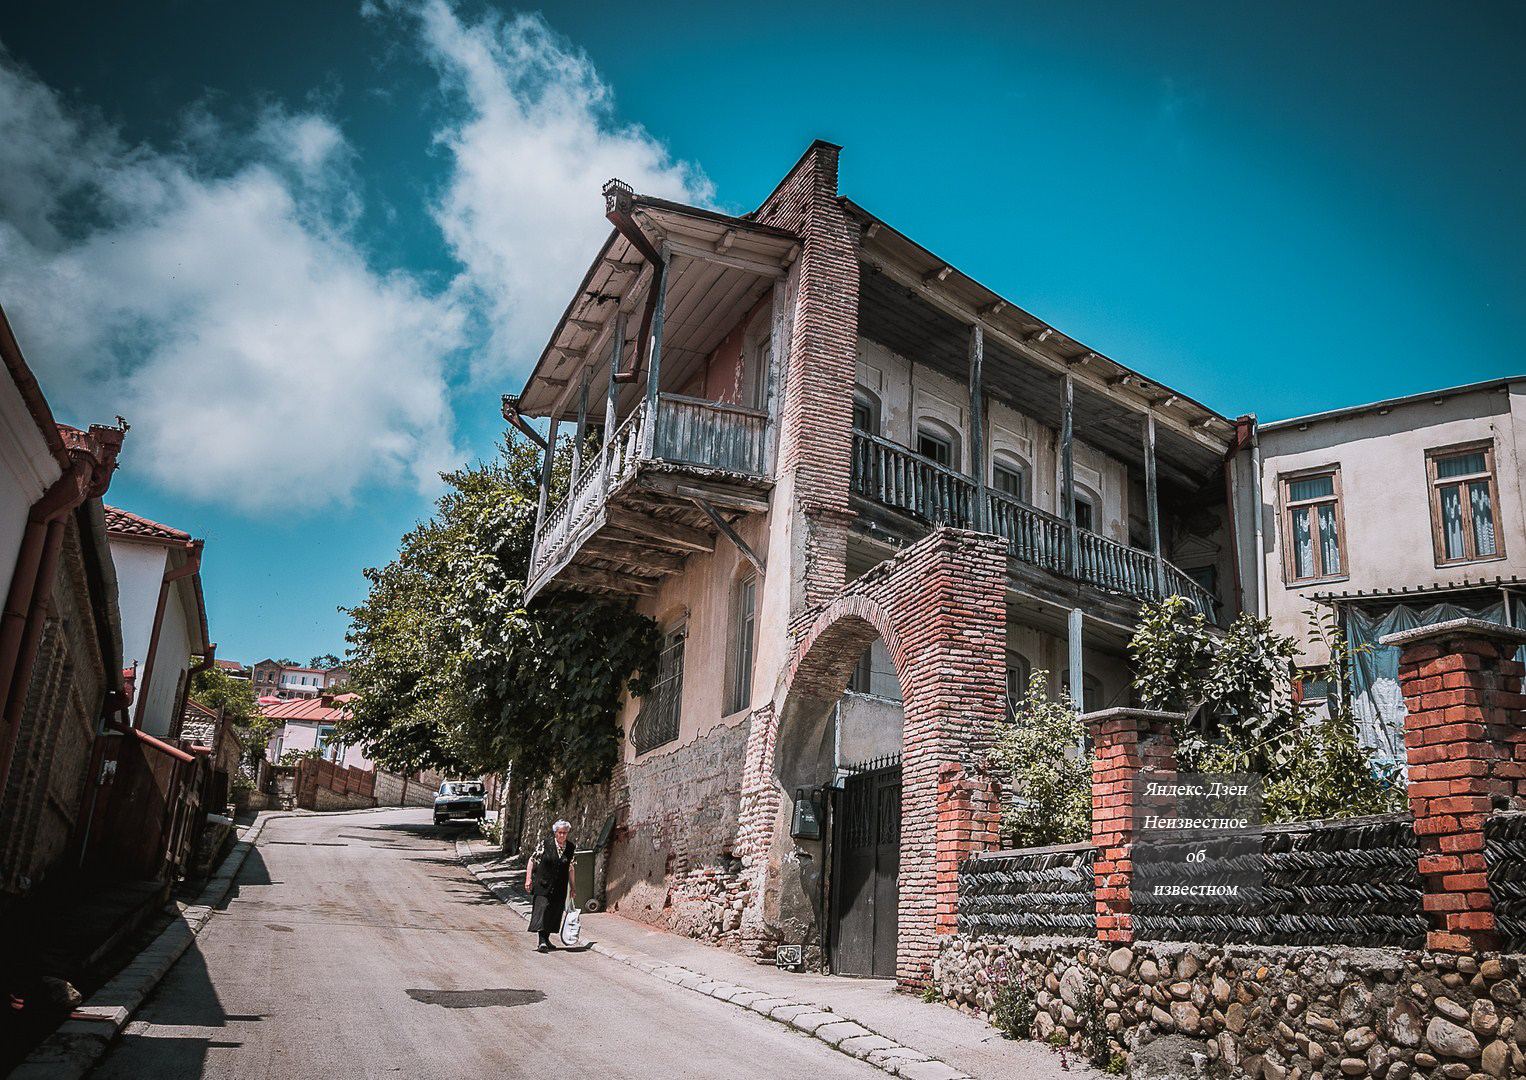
[853,432,1218,622]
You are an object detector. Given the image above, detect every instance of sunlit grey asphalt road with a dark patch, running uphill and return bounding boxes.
[92,810,885,1080]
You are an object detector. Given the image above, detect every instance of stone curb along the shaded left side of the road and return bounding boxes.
[9,807,409,1080]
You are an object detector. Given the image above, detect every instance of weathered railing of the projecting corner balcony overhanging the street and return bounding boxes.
[530,394,768,580]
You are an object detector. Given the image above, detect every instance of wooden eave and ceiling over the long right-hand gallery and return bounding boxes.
[839,198,1235,491]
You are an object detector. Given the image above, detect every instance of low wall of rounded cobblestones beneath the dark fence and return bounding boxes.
[934,934,1526,1080]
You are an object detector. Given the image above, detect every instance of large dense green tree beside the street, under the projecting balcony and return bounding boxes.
[340,439,658,786]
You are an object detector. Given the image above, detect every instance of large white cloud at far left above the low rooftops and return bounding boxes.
[0,53,464,511]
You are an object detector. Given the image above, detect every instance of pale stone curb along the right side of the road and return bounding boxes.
[456,836,971,1080]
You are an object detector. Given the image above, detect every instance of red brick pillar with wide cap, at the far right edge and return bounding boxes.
[1383,619,1526,952]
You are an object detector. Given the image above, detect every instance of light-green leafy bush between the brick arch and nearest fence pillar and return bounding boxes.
[990,671,1091,848]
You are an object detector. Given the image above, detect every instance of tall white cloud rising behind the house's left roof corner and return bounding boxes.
[381,0,714,379]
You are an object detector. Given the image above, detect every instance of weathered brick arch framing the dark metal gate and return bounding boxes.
[749,529,1007,985]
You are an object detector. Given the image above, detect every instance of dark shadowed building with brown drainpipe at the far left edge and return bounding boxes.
[0,313,124,909]
